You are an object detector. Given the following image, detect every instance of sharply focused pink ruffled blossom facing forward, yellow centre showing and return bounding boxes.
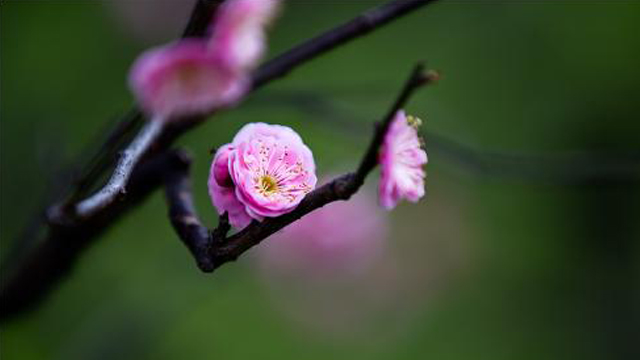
[209,123,317,228]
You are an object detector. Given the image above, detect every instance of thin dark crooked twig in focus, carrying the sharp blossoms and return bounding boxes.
[167,64,437,272]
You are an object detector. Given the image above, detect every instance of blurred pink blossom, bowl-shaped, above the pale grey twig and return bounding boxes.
[129,39,248,119]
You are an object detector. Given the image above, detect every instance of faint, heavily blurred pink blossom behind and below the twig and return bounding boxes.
[258,187,388,281]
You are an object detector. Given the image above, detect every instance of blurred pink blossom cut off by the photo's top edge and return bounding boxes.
[209,0,280,71]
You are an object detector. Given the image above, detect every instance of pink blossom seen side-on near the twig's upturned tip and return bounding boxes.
[378,110,428,210]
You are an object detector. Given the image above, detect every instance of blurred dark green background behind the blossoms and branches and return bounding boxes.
[0,0,640,360]
